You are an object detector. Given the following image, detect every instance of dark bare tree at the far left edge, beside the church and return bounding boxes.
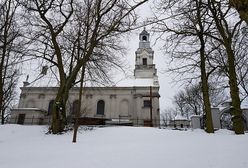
[0,0,24,124]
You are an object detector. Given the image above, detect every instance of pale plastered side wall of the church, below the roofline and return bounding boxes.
[19,87,160,123]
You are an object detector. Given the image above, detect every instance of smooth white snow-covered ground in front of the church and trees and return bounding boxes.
[0,125,248,168]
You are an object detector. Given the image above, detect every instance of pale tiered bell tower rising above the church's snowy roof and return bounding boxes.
[134,28,158,80]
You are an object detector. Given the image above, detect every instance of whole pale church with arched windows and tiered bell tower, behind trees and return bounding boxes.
[10,29,160,126]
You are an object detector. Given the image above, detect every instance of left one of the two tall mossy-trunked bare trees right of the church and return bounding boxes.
[153,0,216,133]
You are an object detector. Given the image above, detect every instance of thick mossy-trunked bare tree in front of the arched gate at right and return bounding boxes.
[208,0,244,134]
